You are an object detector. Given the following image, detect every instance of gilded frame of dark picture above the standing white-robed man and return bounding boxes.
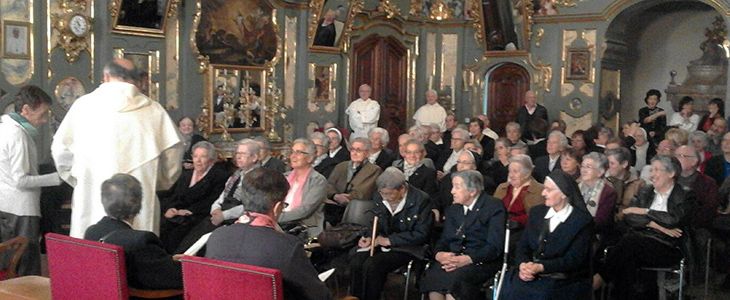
[109,0,180,38]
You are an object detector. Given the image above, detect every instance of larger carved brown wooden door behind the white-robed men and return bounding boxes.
[350,34,408,149]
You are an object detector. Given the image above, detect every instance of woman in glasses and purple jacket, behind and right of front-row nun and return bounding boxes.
[578,152,618,234]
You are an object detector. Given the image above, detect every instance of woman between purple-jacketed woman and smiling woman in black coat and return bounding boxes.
[605,147,644,220]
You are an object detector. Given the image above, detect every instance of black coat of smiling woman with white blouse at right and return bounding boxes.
[624,183,696,246]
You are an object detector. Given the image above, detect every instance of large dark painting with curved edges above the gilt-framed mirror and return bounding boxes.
[194,0,279,66]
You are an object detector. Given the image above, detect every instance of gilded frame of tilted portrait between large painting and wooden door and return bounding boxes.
[307,0,364,53]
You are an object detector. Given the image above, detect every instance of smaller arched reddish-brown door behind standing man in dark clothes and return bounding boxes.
[487,63,530,136]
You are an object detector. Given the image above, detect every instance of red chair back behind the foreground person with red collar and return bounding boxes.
[180,256,284,300]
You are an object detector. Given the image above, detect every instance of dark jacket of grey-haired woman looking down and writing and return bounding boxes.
[367,185,433,259]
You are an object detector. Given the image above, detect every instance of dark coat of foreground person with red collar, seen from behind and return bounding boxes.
[205,223,332,300]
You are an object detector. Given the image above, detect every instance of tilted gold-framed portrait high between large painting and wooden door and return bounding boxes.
[309,0,362,51]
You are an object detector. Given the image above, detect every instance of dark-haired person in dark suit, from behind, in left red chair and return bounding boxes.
[84,174,183,289]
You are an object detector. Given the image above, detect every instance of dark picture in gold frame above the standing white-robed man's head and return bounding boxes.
[110,0,180,37]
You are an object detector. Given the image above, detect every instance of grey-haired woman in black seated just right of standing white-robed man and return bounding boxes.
[158,141,228,253]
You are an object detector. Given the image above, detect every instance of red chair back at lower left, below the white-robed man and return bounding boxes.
[46,233,129,300]
